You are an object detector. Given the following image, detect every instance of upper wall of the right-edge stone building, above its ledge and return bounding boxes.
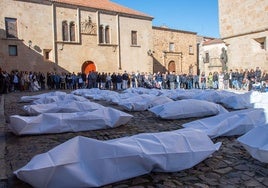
[219,0,268,38]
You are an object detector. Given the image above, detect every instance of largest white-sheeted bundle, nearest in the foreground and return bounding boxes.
[14,129,220,188]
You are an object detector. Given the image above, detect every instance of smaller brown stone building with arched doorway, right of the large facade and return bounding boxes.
[152,27,198,74]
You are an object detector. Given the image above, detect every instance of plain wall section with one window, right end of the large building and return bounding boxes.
[119,17,153,72]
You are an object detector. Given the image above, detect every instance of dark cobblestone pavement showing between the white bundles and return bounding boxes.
[0,92,268,188]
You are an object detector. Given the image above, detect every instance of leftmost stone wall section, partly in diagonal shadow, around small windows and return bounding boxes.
[0,0,54,71]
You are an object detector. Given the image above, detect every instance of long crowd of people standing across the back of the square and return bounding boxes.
[0,67,268,93]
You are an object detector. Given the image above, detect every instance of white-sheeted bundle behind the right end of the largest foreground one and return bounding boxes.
[182,109,267,138]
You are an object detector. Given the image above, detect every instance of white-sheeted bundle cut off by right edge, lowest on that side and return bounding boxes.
[237,124,268,163]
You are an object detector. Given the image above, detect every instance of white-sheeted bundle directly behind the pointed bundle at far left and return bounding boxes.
[23,99,104,115]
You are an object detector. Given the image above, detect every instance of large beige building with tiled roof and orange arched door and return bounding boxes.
[0,0,153,73]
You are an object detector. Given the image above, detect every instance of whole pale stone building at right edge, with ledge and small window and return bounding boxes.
[218,0,268,70]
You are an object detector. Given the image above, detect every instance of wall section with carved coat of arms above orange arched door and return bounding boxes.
[57,8,118,73]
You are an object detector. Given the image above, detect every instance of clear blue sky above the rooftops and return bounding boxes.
[111,0,220,38]
